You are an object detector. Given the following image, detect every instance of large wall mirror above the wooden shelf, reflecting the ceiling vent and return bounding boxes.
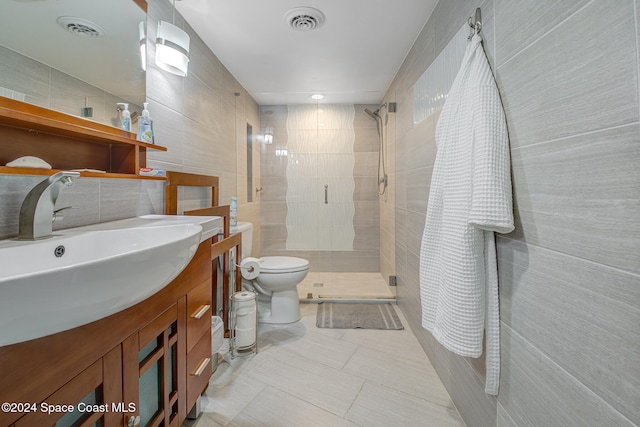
[0,0,146,127]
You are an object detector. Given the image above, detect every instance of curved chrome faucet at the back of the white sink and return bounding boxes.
[18,171,80,240]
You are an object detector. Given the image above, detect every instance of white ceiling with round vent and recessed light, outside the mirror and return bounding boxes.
[176,0,437,105]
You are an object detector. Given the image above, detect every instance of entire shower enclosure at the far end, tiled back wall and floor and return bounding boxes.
[260,104,393,300]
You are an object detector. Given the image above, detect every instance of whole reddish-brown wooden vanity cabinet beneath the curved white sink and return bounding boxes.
[0,239,212,427]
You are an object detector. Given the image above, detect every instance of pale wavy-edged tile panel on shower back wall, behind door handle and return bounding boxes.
[286,105,355,251]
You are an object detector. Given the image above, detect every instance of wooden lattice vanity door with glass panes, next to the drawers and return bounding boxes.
[122,297,186,427]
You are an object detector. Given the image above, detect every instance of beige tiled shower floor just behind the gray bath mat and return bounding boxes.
[298,272,395,301]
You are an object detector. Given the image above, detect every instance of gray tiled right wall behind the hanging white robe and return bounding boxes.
[388,0,640,427]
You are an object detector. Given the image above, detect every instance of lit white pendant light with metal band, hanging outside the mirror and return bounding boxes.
[156,0,191,77]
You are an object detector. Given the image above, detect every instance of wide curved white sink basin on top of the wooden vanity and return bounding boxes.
[0,215,220,346]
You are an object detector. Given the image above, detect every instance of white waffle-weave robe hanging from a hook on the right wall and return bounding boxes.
[420,34,514,394]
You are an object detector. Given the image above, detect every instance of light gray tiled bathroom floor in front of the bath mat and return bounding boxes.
[185,304,464,427]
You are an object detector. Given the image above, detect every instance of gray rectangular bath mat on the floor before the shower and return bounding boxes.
[316,302,404,329]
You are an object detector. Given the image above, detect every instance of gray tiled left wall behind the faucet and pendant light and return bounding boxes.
[0,0,260,247]
